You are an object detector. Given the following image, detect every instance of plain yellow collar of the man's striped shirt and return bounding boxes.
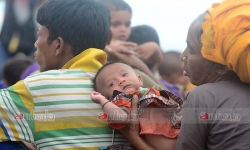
[62,48,107,73]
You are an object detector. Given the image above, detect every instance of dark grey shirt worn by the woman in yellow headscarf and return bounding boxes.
[175,81,250,150]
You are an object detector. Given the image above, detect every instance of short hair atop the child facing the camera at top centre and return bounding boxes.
[102,0,132,14]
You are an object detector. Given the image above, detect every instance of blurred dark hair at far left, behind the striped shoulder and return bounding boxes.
[3,57,33,86]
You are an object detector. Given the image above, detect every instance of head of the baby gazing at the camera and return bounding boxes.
[94,62,143,99]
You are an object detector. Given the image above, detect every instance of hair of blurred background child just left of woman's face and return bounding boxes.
[158,51,182,76]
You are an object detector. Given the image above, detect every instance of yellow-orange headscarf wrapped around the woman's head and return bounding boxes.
[201,0,250,83]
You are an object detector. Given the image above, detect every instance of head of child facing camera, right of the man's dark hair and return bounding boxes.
[103,0,132,41]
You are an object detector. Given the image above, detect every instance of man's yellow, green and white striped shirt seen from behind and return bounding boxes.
[0,49,125,150]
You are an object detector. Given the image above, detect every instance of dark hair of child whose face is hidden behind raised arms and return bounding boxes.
[128,25,160,45]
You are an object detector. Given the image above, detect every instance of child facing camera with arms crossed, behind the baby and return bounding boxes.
[102,0,164,88]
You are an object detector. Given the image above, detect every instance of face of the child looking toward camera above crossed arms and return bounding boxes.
[110,10,131,41]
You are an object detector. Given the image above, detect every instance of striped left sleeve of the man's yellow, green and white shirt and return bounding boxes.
[0,81,34,142]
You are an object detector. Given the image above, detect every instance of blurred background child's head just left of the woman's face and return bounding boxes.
[158,51,188,85]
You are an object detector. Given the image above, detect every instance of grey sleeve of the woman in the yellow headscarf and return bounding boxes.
[175,89,209,150]
